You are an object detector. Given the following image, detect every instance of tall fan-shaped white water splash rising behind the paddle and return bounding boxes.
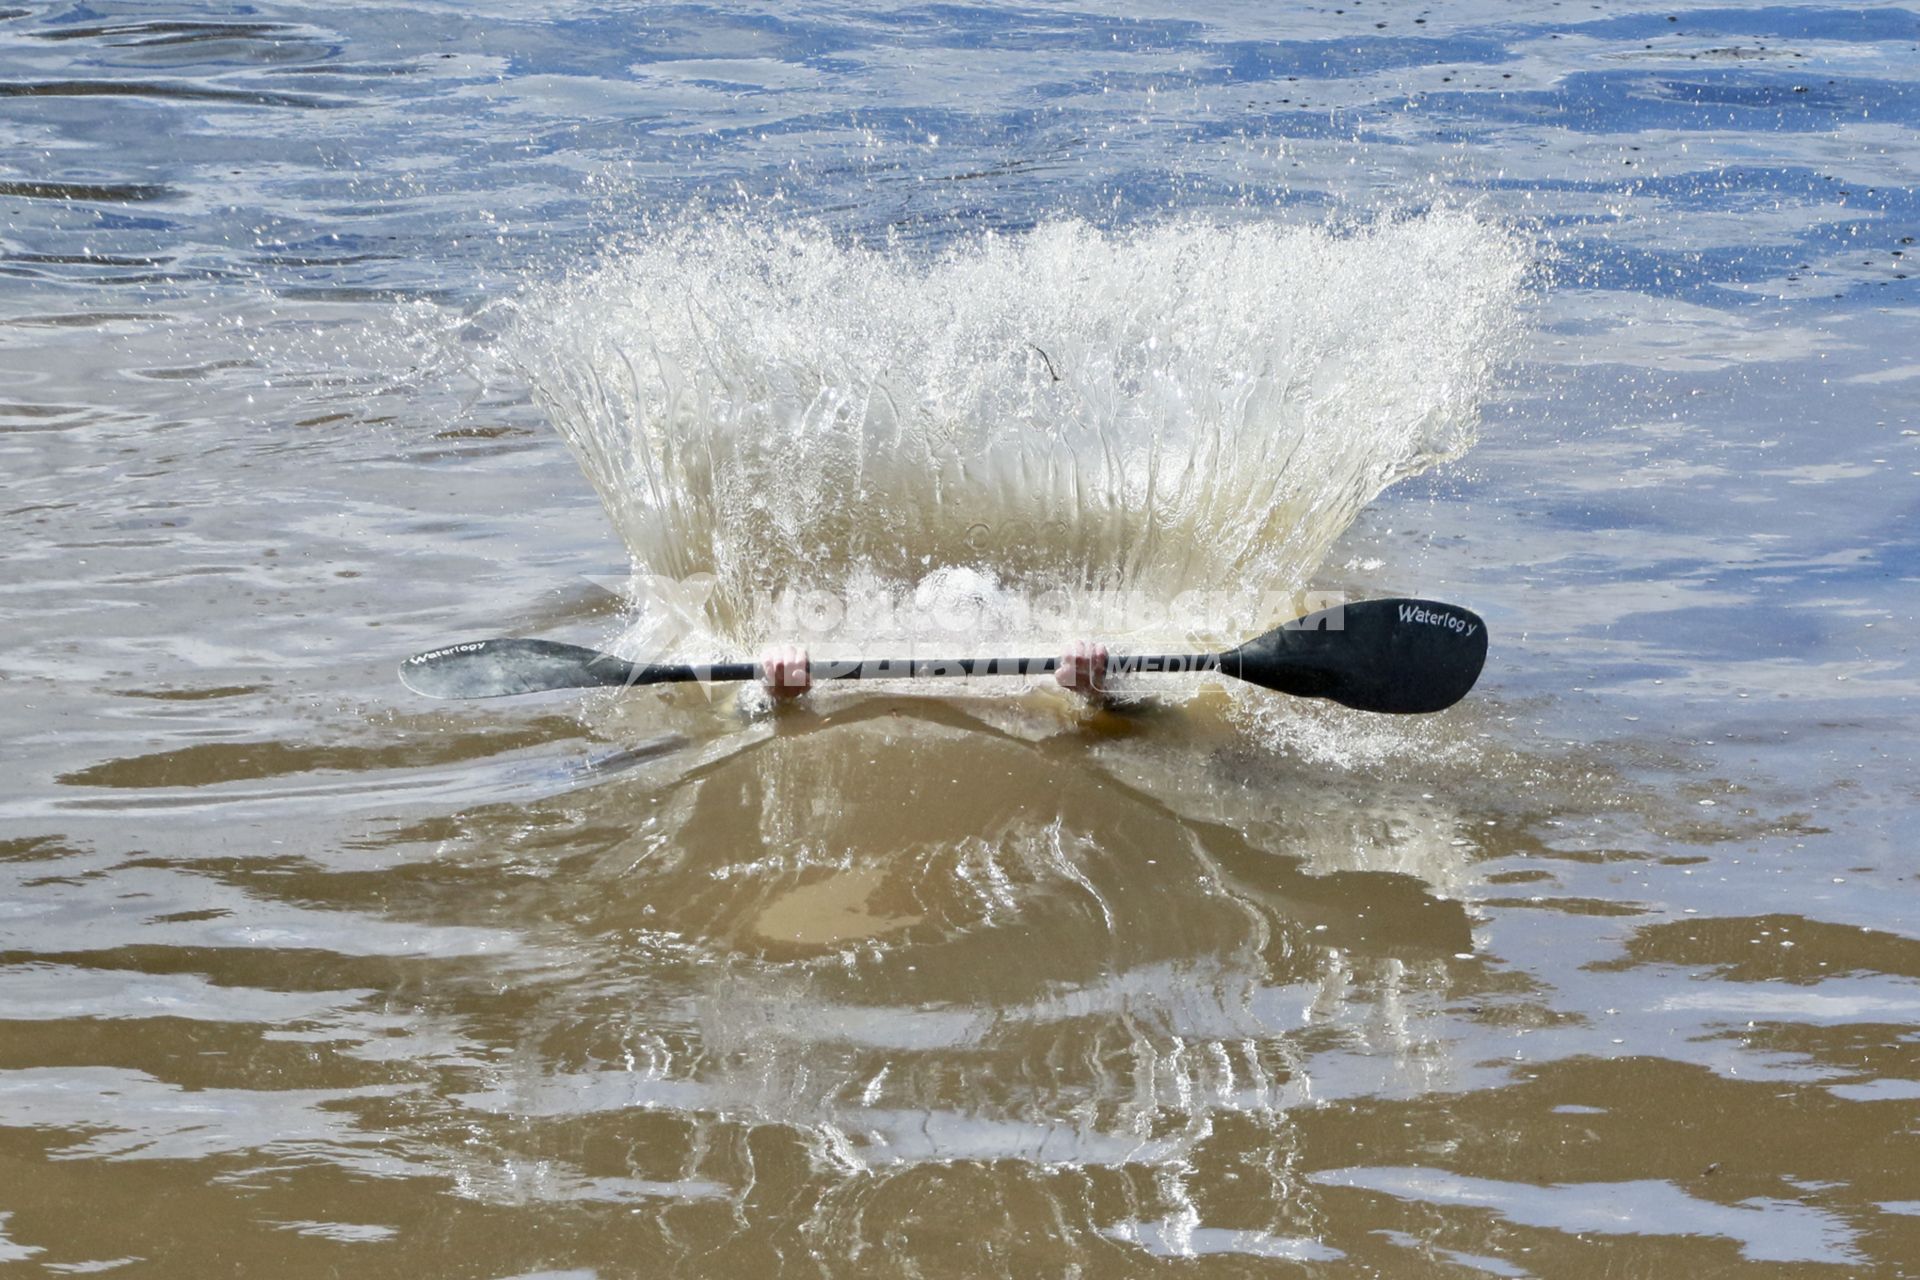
[507,213,1526,654]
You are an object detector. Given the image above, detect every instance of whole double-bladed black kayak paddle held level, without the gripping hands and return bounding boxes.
[399,599,1486,714]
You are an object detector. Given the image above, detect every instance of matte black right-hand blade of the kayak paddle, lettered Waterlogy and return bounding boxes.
[1219,599,1486,714]
